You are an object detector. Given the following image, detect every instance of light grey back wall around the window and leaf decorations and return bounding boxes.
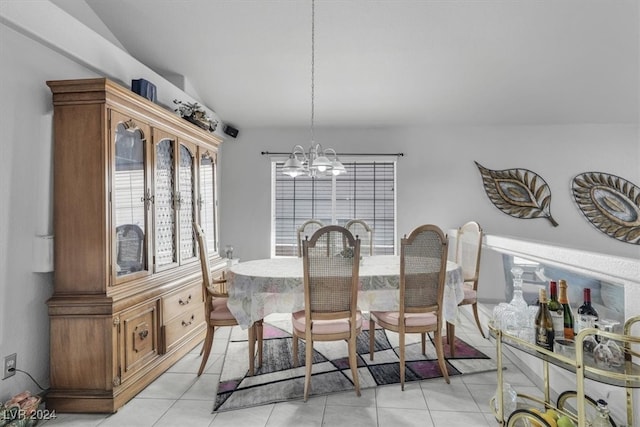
[220,125,640,260]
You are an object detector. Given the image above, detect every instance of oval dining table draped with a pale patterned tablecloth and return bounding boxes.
[227,255,464,329]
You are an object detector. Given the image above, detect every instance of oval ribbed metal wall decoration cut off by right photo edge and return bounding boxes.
[571,172,640,245]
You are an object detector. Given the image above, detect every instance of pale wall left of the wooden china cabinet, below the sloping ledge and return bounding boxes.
[0,20,97,400]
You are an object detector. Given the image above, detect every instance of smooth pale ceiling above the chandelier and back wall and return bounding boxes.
[53,0,640,128]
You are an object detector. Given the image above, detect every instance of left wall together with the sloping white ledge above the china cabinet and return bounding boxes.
[0,1,221,401]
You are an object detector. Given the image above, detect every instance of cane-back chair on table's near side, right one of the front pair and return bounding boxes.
[369,224,449,390]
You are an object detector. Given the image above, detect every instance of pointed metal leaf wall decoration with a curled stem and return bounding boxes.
[475,162,558,227]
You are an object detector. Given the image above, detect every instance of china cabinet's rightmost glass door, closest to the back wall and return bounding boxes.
[199,151,218,253]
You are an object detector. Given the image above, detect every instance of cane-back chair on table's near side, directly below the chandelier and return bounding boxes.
[292,225,362,402]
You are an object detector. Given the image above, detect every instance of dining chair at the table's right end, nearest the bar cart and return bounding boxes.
[447,221,486,356]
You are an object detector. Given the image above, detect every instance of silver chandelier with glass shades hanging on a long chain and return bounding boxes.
[282,0,347,178]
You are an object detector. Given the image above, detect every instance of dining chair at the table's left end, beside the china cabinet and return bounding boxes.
[193,222,262,376]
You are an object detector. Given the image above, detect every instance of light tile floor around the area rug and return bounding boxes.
[41,307,542,427]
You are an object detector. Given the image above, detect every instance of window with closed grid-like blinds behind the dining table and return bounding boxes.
[271,161,396,256]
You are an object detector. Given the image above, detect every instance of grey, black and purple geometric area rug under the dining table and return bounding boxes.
[213,320,496,412]
